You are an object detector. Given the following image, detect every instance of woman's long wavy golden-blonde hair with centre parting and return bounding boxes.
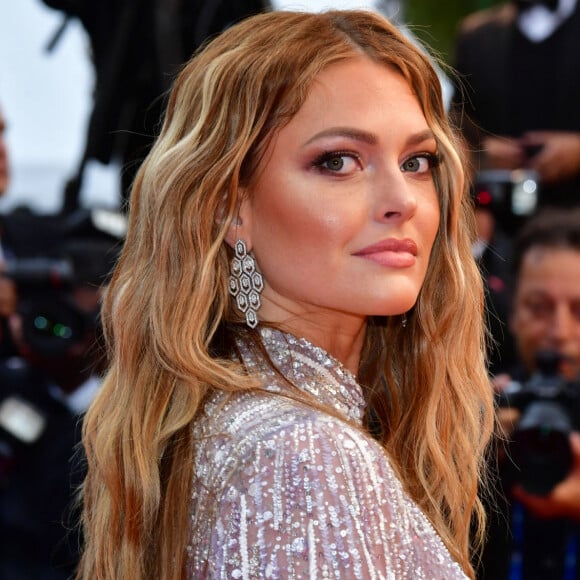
[78,6,493,580]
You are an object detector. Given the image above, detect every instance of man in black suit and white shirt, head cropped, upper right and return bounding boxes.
[453,0,580,212]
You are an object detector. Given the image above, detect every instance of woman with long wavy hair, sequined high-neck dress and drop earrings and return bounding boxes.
[79,11,493,579]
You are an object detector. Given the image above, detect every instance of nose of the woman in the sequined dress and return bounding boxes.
[375,166,418,221]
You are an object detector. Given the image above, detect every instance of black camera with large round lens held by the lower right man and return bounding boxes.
[498,351,580,495]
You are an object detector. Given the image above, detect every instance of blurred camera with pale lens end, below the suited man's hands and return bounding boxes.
[472,169,540,231]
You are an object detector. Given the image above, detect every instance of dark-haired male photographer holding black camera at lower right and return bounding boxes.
[480,209,580,580]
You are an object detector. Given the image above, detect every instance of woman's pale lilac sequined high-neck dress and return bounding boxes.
[188,329,466,580]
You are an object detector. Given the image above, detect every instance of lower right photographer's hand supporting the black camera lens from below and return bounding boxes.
[512,433,580,522]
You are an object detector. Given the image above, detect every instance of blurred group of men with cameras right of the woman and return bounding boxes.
[451,0,580,580]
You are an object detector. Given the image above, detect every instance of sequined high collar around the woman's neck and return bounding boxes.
[238,328,365,424]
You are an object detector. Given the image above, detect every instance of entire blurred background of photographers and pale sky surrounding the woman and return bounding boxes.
[0,0,580,580]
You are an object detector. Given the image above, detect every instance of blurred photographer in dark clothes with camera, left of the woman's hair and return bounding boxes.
[0,227,117,580]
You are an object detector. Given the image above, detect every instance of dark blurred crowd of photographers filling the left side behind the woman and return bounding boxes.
[0,0,267,580]
